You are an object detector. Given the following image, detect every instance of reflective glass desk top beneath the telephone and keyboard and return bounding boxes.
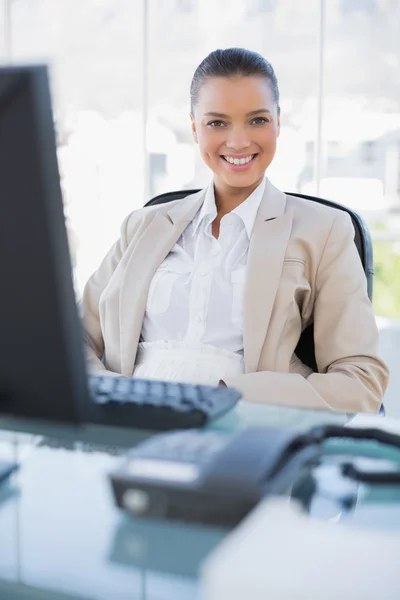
[0,403,400,600]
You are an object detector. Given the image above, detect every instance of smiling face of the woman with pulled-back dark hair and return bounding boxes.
[191,76,280,188]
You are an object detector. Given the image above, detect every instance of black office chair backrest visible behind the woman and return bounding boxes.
[146,190,374,372]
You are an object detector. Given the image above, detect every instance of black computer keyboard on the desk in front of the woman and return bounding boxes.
[89,375,241,431]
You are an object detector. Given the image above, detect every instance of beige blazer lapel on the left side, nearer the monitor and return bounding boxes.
[119,190,205,377]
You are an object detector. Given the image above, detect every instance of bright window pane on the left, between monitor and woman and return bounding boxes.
[11,0,145,294]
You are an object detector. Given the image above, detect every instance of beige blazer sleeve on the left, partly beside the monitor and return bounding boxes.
[79,215,131,375]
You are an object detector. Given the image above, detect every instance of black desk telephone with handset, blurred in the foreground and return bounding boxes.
[110,425,400,526]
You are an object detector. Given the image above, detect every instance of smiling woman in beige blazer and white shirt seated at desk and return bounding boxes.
[82,48,388,412]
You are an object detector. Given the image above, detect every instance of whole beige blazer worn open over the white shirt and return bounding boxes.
[81,180,388,412]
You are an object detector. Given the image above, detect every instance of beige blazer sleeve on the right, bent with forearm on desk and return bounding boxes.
[225,211,389,412]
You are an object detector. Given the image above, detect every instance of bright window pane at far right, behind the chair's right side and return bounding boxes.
[321,0,400,414]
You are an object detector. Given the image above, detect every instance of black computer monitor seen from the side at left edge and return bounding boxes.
[0,66,88,422]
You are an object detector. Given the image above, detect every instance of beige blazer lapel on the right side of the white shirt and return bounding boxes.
[243,179,292,373]
